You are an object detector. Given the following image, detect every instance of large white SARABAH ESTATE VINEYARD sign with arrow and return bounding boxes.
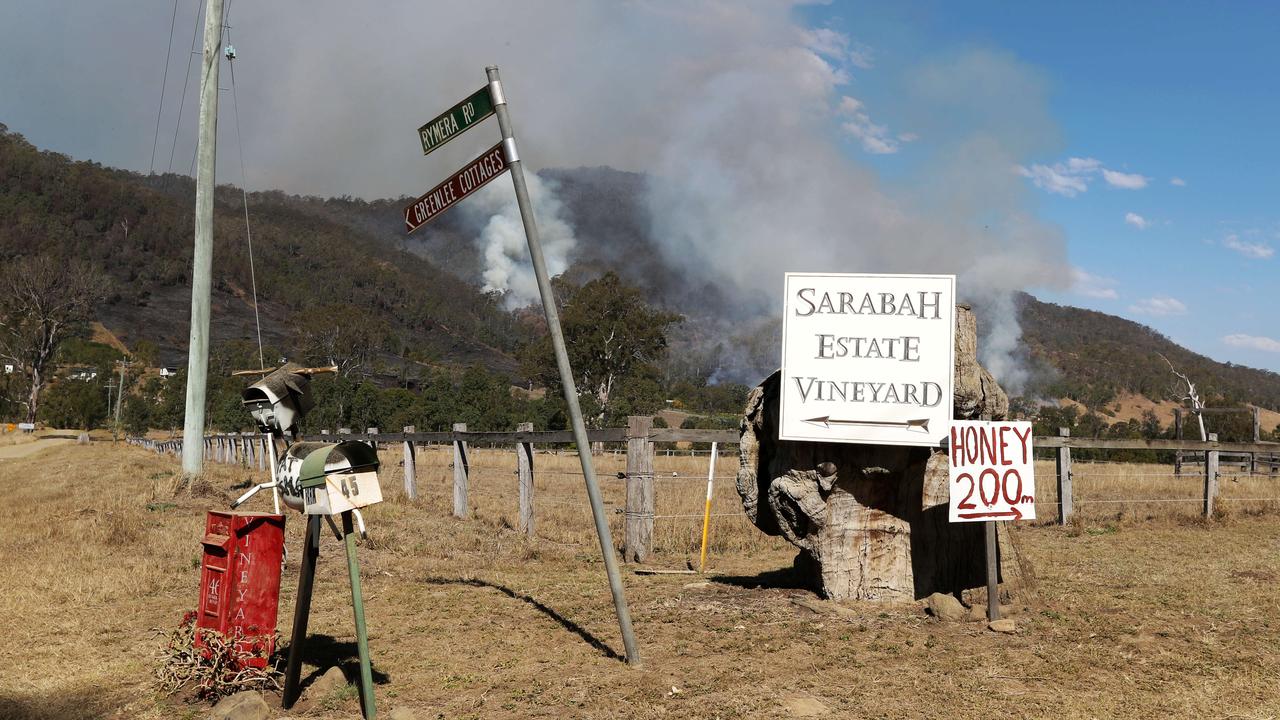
[778,273,956,446]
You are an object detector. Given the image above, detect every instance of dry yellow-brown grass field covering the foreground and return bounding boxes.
[0,442,1280,720]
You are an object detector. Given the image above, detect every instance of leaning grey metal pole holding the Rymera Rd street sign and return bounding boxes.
[485,65,640,665]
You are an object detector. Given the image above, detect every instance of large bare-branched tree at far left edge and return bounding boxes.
[0,255,105,423]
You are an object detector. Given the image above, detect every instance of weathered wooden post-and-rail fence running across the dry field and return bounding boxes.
[129,416,1280,562]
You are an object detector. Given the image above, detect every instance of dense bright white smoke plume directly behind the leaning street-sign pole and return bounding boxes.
[461,173,577,309]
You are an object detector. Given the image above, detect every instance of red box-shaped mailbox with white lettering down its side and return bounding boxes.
[196,510,284,667]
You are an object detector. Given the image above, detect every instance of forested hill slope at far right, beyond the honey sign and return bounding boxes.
[1018,293,1280,411]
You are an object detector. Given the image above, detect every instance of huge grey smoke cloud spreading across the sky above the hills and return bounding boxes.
[0,0,1069,391]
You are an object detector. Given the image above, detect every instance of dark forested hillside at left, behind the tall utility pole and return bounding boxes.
[0,124,522,372]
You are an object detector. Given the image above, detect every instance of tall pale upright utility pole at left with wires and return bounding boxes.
[182,0,223,475]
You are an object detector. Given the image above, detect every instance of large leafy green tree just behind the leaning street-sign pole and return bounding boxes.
[520,273,684,427]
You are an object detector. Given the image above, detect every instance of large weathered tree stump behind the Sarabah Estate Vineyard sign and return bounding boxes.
[737,305,1023,601]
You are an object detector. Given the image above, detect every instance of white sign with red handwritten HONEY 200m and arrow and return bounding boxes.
[948,420,1036,523]
